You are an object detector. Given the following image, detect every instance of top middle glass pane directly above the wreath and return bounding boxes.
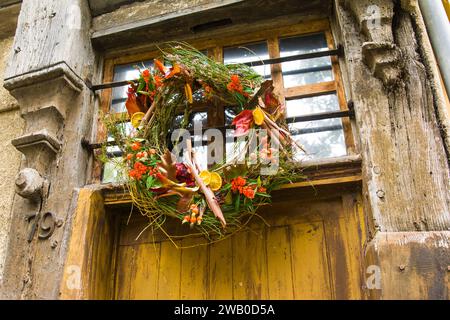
[223,41,271,79]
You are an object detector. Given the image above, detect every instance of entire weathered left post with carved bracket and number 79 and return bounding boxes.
[0,0,95,299]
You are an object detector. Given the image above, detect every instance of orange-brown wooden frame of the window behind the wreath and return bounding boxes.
[92,19,356,183]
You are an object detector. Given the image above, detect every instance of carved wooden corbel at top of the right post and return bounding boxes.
[344,0,401,87]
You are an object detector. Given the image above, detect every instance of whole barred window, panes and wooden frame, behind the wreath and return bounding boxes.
[96,22,354,182]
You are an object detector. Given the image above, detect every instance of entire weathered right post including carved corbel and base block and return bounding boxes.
[334,0,450,299]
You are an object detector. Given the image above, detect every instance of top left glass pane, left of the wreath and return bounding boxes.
[111,61,153,113]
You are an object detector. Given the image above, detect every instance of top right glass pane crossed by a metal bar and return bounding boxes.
[280,33,333,88]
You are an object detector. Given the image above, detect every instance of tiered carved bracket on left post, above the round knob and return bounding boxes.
[4,63,84,176]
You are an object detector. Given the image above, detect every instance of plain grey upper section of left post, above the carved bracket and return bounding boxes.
[5,0,95,79]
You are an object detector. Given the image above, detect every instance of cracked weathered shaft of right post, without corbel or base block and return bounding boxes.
[336,1,450,232]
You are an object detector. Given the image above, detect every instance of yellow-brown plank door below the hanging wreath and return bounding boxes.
[111,185,366,299]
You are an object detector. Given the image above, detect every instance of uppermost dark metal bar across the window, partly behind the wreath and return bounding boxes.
[91,46,343,91]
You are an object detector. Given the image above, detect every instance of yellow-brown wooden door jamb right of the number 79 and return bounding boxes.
[60,189,118,299]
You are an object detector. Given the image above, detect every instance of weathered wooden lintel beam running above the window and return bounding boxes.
[92,0,331,50]
